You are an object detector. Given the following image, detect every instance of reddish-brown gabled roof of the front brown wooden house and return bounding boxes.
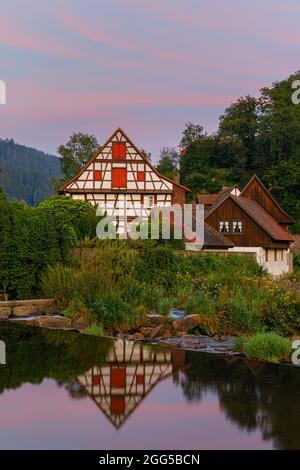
[205,194,293,242]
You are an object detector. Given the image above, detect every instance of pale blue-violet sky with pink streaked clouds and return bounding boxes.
[0,0,300,159]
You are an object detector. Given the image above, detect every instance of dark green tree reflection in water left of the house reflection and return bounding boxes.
[0,322,111,393]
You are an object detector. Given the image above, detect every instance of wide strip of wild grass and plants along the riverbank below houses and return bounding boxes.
[43,240,300,336]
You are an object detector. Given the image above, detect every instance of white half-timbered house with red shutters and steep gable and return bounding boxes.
[60,128,189,233]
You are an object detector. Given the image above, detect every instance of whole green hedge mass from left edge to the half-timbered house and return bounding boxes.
[0,193,95,299]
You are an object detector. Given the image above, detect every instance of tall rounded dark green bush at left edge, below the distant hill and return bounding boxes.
[0,194,71,299]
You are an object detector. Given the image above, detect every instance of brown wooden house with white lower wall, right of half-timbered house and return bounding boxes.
[198,176,293,275]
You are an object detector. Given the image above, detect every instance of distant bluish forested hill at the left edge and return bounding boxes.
[0,139,61,206]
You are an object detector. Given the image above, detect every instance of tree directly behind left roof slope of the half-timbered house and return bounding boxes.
[57,132,100,179]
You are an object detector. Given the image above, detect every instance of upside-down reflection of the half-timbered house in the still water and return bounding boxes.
[77,340,185,428]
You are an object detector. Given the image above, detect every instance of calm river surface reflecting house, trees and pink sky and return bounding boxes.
[0,323,300,449]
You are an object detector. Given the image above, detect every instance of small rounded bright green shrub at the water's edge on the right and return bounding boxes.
[237,333,291,362]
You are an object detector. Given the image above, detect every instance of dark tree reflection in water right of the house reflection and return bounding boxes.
[180,353,300,449]
